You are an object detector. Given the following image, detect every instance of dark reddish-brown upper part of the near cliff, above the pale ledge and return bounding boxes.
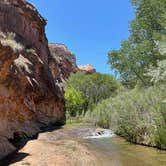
[0,0,48,63]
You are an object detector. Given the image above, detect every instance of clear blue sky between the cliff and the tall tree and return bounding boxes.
[29,0,133,73]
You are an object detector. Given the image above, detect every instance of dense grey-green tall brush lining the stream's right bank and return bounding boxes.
[85,86,166,149]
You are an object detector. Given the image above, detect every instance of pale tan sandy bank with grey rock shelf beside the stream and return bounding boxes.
[4,125,102,166]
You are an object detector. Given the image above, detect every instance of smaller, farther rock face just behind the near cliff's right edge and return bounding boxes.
[49,44,78,81]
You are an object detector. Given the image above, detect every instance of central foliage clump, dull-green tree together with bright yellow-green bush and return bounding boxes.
[65,72,119,116]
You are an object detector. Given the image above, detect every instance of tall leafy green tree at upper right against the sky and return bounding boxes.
[108,0,166,85]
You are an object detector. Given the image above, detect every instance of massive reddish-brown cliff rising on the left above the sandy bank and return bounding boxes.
[0,0,68,159]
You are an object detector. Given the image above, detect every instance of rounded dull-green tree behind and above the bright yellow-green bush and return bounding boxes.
[65,72,119,110]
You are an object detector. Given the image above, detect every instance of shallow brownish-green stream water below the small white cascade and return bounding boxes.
[85,132,166,166]
